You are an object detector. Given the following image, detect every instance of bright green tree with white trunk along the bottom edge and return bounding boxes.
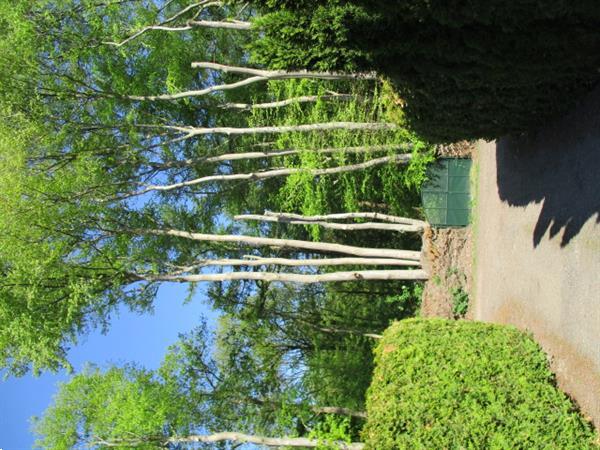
[35,326,362,449]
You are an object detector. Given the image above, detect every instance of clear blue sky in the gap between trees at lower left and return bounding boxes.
[0,284,216,450]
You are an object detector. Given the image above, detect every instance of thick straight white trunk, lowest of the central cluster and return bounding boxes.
[139,270,428,284]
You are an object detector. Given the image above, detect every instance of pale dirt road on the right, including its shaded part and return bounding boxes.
[474,84,600,428]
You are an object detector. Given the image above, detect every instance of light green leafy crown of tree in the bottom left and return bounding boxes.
[34,366,195,450]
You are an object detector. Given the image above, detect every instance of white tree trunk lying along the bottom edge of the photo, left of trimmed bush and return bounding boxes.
[167,432,364,450]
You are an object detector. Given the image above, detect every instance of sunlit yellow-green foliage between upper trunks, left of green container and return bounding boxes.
[237,80,432,234]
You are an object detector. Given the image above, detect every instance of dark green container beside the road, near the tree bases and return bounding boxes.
[421,158,471,227]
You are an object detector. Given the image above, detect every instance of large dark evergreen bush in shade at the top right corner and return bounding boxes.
[241,0,600,142]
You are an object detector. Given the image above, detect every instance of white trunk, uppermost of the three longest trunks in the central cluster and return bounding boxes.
[138,229,421,261]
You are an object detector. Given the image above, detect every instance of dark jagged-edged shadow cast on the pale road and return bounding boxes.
[496,86,600,247]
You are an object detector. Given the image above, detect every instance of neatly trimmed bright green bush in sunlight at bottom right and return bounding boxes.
[363,319,597,450]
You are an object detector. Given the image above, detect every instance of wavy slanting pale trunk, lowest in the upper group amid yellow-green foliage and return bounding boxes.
[124,154,412,199]
